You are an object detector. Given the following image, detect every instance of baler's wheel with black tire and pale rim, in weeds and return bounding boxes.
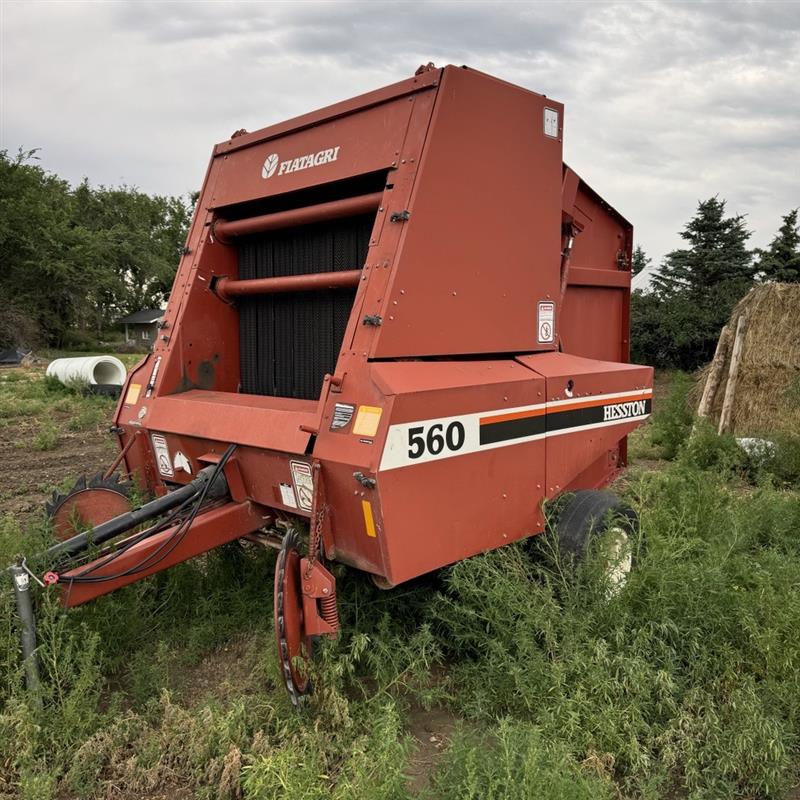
[553,489,639,595]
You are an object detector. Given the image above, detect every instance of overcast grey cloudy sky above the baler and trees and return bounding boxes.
[0,0,800,274]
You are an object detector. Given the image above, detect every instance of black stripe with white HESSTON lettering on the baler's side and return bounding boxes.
[480,399,653,445]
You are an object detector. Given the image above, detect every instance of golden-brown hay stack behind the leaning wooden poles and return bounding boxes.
[693,283,800,435]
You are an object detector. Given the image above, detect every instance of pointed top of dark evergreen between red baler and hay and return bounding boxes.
[653,197,755,296]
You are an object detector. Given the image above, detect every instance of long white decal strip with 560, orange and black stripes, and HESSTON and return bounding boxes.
[379,389,653,471]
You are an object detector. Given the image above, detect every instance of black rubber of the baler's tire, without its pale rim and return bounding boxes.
[554,489,639,566]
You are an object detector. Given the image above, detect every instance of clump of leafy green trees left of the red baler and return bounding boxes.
[0,150,193,347]
